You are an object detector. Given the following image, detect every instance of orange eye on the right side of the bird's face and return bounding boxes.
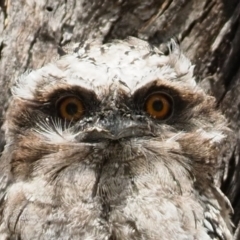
[145,92,173,120]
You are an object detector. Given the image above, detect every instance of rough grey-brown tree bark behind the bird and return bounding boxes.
[0,0,240,236]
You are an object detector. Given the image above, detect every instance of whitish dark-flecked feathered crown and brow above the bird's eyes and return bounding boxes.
[13,41,195,99]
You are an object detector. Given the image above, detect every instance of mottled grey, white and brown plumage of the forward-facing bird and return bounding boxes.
[0,38,232,240]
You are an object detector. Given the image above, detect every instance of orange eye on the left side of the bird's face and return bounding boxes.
[58,97,84,121]
